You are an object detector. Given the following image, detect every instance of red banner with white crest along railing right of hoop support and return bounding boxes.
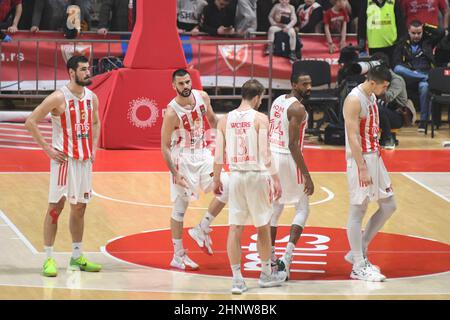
[184,35,356,89]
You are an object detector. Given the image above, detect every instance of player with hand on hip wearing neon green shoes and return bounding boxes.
[25,56,102,277]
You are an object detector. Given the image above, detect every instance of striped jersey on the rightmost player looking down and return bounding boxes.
[345,85,380,158]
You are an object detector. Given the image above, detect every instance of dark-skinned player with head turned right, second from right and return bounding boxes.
[269,73,314,277]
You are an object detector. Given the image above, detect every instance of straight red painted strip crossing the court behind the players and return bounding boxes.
[0,149,450,172]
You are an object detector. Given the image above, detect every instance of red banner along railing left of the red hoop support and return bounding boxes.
[0,32,124,90]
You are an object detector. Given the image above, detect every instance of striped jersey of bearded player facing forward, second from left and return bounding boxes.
[169,89,208,150]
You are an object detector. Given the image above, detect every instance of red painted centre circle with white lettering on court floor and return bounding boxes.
[106,226,450,280]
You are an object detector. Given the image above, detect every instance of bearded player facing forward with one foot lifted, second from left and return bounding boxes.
[161,69,228,270]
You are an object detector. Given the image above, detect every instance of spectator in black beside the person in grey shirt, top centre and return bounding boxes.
[200,0,236,36]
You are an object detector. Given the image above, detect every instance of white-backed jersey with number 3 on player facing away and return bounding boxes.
[226,109,267,171]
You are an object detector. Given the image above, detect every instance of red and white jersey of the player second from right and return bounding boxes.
[269,94,308,153]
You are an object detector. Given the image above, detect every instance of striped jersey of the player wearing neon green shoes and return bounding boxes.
[51,86,94,160]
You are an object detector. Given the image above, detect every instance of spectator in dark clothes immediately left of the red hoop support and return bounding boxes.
[97,0,136,35]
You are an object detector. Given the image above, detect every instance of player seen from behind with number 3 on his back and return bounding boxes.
[214,80,286,294]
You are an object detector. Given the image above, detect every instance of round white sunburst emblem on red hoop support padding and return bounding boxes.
[127,97,159,129]
